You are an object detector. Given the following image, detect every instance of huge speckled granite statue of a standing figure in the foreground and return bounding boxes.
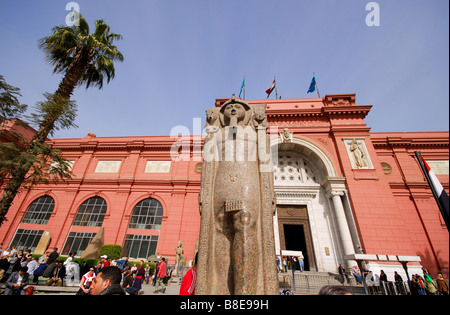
[195,95,279,295]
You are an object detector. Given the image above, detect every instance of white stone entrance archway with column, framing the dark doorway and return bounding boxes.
[271,137,354,272]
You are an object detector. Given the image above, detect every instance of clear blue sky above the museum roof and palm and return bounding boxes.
[0,0,449,138]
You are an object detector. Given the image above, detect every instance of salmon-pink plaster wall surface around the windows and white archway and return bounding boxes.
[0,94,449,275]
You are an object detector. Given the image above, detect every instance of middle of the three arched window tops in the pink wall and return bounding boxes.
[73,197,106,226]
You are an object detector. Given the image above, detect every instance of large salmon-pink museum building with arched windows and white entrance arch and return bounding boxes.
[0,94,449,278]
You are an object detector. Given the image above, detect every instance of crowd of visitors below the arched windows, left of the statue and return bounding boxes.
[0,247,181,295]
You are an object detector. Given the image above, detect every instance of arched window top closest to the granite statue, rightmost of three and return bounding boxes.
[128,198,163,230]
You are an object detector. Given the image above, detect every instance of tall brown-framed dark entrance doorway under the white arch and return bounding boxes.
[277,205,317,270]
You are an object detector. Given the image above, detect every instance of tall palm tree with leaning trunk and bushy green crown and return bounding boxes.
[0,16,124,225]
